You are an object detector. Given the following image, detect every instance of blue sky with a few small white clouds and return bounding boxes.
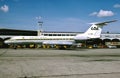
[0,0,120,33]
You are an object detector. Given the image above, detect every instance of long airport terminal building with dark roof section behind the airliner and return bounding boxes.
[0,29,120,48]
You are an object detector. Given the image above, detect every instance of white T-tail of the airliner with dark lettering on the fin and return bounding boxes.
[84,20,117,38]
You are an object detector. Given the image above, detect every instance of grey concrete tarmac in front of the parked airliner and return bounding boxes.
[0,49,120,78]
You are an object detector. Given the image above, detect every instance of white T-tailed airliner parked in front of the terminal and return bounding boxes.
[5,20,116,48]
